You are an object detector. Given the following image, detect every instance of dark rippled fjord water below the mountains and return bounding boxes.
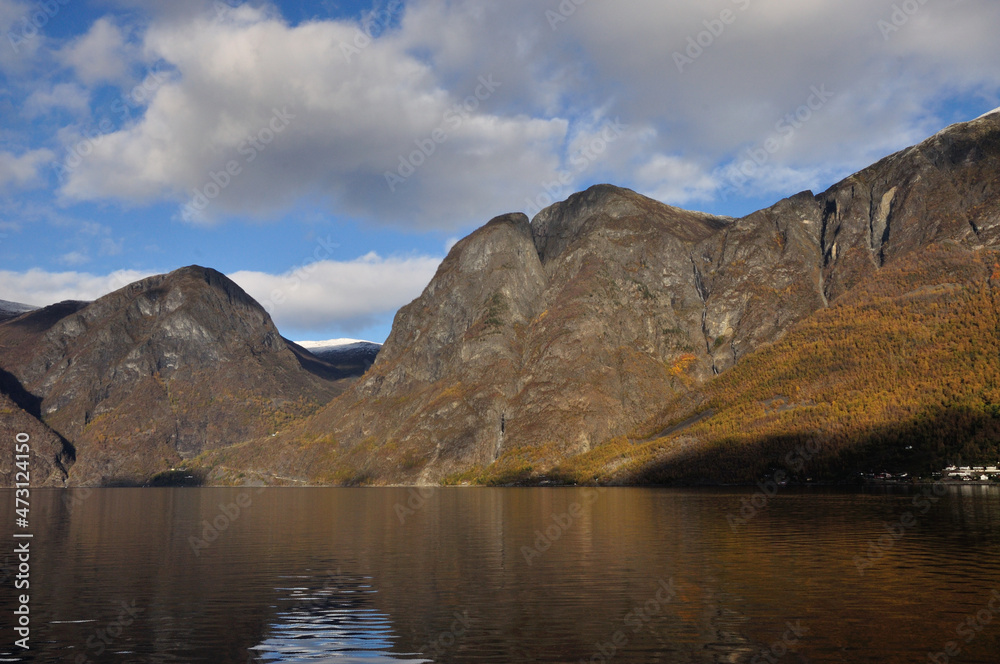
[0,486,1000,664]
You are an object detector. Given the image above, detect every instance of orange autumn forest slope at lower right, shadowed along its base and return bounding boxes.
[576,239,1000,484]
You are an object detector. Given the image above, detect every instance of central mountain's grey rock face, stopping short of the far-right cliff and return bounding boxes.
[290,185,823,482]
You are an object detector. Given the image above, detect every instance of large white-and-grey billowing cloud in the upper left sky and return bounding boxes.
[54,5,567,227]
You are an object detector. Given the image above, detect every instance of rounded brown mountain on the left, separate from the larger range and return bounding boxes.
[0,266,345,484]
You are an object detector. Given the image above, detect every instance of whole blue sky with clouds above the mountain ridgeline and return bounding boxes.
[0,0,1000,342]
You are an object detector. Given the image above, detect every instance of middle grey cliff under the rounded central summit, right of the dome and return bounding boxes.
[508,185,729,455]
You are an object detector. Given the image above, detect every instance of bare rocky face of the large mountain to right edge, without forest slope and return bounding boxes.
[270,107,1000,482]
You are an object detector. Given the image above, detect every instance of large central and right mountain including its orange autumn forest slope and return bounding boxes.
[197,107,1000,484]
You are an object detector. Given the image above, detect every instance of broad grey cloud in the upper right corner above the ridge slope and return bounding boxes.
[555,0,1000,176]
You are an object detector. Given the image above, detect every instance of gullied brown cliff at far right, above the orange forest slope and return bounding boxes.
[817,113,1000,299]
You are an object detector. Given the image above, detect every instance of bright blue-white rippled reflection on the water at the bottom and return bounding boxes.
[250,570,431,664]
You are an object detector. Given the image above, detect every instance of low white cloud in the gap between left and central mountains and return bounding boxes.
[228,253,441,332]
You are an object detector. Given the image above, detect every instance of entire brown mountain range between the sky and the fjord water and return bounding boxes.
[0,107,1000,486]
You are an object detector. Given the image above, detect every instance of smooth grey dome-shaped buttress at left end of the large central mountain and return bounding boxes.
[286,214,546,481]
